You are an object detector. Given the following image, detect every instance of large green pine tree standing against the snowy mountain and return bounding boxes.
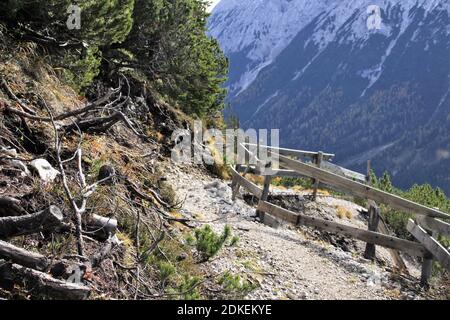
[118,0,228,116]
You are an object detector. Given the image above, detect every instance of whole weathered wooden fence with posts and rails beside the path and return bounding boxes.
[231,144,450,286]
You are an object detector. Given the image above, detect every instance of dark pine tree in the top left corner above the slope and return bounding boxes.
[0,0,134,90]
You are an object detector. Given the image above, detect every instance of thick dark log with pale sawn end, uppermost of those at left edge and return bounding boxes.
[0,206,64,239]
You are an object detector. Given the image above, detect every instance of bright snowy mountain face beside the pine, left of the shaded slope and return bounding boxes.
[210,0,332,92]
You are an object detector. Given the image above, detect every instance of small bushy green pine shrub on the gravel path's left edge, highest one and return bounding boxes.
[195,225,231,261]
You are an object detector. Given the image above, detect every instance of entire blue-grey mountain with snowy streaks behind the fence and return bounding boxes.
[209,0,450,193]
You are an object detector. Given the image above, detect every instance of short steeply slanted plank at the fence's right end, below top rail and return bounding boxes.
[406,219,450,271]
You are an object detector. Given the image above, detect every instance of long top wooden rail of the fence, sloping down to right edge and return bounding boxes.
[279,155,450,219]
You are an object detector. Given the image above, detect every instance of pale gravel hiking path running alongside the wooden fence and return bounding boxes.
[166,165,417,299]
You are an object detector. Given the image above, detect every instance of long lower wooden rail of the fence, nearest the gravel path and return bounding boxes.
[258,201,428,257]
